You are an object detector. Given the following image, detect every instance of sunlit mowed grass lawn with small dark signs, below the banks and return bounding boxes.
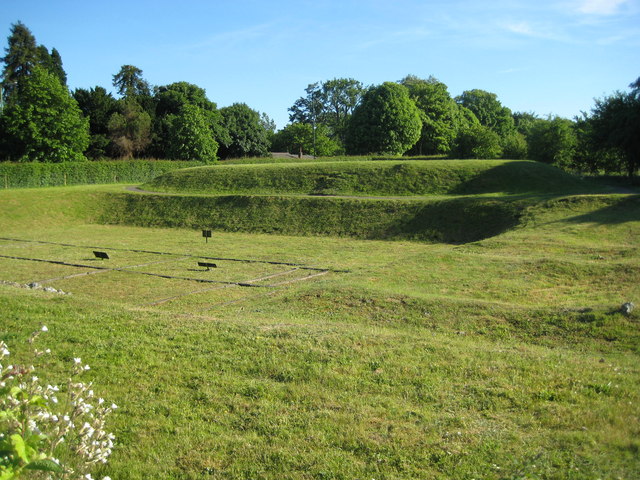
[0,186,640,480]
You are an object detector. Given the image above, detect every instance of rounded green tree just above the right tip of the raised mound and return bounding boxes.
[527,117,578,168]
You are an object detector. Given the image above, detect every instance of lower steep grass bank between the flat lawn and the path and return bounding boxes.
[100,193,526,243]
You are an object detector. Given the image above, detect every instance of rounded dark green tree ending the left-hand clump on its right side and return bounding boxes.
[220,103,270,158]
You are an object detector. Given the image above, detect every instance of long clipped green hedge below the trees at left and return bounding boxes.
[0,160,202,188]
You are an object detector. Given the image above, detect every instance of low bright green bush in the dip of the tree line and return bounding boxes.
[273,123,341,157]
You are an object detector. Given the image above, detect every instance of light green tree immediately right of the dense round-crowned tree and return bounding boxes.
[400,75,459,155]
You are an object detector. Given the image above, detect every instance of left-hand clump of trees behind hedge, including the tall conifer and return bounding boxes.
[0,22,275,162]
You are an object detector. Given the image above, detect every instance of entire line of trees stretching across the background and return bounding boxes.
[0,22,640,176]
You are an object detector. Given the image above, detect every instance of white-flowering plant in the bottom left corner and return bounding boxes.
[0,326,117,480]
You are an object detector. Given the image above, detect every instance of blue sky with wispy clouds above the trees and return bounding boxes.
[0,0,640,128]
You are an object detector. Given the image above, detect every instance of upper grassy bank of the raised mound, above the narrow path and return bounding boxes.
[144,160,603,196]
